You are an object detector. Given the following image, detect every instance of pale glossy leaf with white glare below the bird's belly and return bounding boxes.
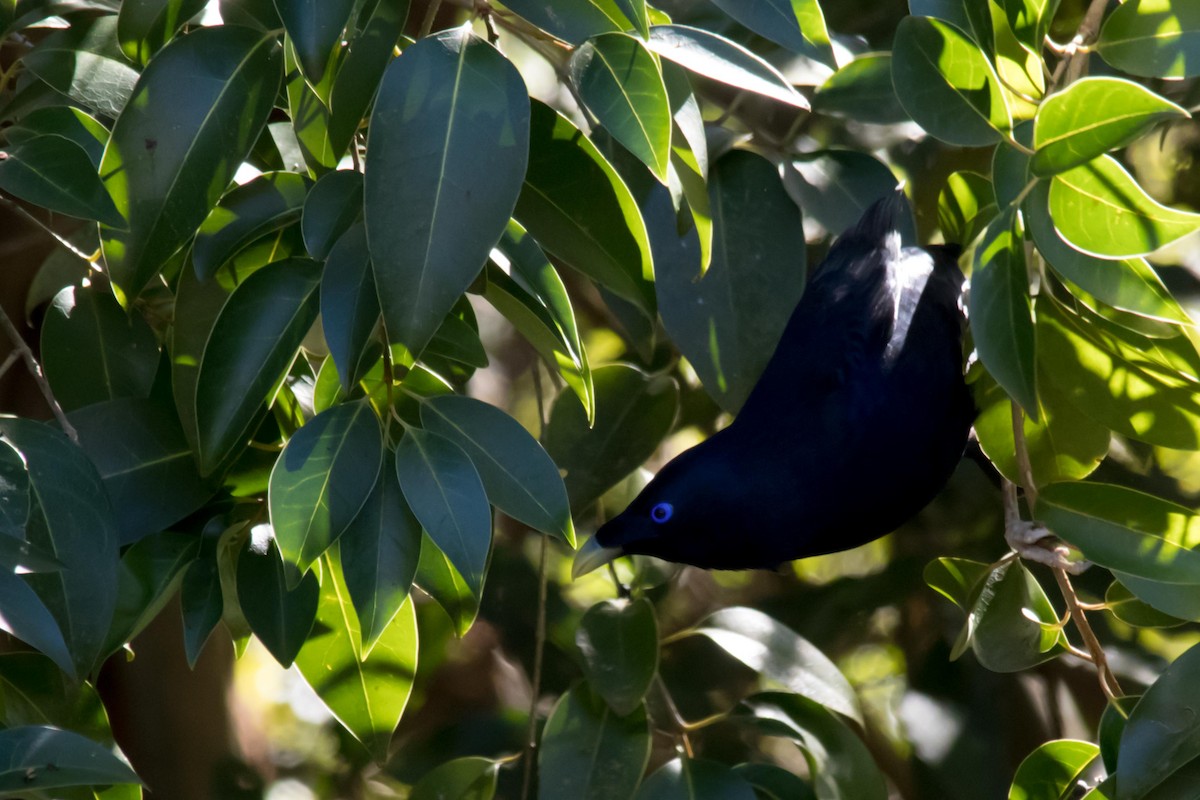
[694,607,863,722]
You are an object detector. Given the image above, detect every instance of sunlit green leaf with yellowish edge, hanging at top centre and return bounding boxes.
[570,34,671,184]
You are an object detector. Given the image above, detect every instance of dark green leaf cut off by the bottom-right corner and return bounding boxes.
[1115,646,1200,800]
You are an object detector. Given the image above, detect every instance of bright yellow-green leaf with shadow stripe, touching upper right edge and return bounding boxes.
[1049,156,1200,258]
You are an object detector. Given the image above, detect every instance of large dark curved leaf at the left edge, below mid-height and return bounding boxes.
[0,417,118,678]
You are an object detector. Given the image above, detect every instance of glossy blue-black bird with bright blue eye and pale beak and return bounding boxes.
[574,191,976,576]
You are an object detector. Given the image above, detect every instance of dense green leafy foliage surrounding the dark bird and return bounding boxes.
[0,0,1200,800]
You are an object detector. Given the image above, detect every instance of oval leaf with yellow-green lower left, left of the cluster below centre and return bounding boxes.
[268,401,383,588]
